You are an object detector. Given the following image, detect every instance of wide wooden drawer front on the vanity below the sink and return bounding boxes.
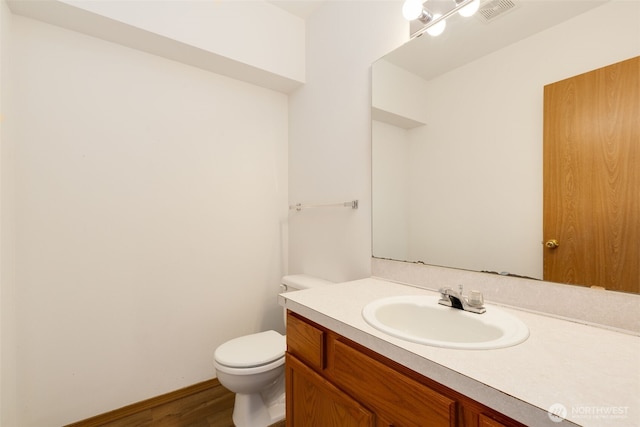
[332,340,457,427]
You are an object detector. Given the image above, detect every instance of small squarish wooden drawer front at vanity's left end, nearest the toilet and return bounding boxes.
[287,313,325,371]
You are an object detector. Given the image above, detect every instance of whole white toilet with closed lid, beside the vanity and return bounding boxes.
[213,274,332,427]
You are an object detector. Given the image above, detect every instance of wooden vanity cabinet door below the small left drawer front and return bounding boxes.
[286,354,375,427]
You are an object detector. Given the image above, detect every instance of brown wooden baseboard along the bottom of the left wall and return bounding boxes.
[65,378,222,427]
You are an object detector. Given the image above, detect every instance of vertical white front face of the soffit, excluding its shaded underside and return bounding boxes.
[58,0,305,82]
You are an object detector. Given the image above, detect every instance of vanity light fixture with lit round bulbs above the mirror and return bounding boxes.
[402,0,480,38]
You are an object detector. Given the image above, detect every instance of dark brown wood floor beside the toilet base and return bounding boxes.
[67,380,285,427]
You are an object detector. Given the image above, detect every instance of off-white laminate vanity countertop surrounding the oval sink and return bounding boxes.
[279,278,640,427]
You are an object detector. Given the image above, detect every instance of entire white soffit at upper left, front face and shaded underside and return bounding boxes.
[7,0,305,93]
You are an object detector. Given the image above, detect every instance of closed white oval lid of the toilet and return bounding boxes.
[214,331,287,368]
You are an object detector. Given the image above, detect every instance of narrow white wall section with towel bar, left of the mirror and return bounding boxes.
[289,0,409,281]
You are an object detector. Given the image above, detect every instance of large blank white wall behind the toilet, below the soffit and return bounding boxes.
[2,16,288,427]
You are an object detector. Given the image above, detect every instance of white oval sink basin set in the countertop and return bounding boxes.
[362,295,529,350]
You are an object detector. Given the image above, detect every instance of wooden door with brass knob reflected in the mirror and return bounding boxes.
[543,57,640,292]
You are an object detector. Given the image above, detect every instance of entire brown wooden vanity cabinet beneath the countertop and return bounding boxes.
[286,312,524,427]
